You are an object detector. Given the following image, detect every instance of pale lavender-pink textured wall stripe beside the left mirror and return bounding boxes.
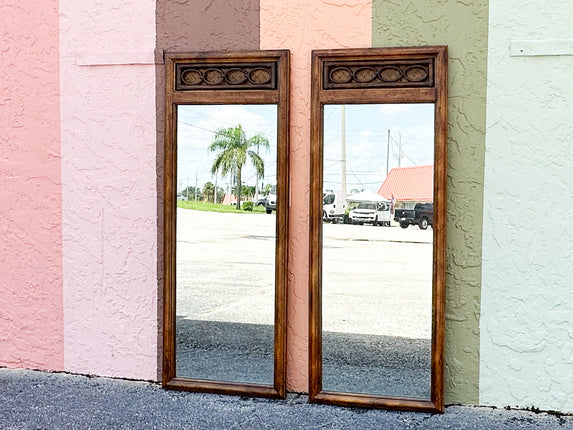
[60,0,157,379]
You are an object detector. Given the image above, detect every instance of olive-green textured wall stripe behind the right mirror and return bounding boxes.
[372,0,488,404]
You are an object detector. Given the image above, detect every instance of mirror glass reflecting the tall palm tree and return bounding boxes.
[175,105,277,385]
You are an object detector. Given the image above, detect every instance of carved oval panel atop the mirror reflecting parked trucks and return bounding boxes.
[323,58,434,90]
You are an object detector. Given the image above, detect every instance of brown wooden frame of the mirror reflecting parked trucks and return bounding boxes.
[309,46,448,412]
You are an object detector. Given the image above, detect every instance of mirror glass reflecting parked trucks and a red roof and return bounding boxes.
[322,103,434,399]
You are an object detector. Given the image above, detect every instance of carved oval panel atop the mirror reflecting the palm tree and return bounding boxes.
[175,62,277,91]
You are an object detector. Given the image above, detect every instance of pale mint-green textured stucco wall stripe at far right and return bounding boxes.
[480,0,573,412]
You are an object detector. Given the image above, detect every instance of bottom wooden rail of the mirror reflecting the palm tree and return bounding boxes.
[163,378,285,399]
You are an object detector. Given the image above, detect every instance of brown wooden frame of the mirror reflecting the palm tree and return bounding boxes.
[162,50,290,398]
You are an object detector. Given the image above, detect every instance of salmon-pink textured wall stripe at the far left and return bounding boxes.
[0,0,63,370]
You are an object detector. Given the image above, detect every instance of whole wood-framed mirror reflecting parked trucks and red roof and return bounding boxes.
[309,46,447,412]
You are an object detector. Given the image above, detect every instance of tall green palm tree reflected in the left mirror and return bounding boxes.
[209,124,270,209]
